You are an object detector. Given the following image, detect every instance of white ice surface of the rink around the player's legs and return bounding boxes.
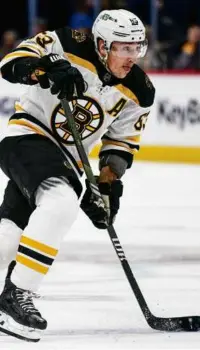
[0,161,200,350]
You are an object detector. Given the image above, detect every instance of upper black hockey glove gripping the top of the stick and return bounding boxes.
[35,54,85,100]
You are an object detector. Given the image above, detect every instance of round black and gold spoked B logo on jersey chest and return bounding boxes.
[51,96,103,144]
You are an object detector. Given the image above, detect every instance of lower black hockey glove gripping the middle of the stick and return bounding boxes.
[80,180,123,229]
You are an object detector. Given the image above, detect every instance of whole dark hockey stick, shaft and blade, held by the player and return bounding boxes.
[61,99,200,331]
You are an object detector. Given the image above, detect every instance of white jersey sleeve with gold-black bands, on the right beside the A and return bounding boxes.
[100,101,150,168]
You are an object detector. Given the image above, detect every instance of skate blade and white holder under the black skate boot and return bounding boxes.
[0,311,42,343]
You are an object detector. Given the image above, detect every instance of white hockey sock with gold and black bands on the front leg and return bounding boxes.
[11,178,79,291]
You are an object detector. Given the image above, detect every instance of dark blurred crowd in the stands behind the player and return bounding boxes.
[0,0,200,71]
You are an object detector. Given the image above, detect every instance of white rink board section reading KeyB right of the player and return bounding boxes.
[142,74,200,147]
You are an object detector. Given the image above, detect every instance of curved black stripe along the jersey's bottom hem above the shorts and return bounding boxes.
[9,113,83,175]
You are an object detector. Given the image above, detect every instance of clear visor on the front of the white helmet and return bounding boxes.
[110,40,147,60]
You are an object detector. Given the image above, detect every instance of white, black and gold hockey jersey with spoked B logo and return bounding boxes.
[0,27,155,175]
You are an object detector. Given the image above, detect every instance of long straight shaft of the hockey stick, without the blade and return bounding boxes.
[61,99,152,320]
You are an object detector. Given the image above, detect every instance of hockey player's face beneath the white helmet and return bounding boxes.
[107,42,140,79]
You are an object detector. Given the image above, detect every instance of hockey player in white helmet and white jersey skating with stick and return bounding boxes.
[0,10,155,341]
